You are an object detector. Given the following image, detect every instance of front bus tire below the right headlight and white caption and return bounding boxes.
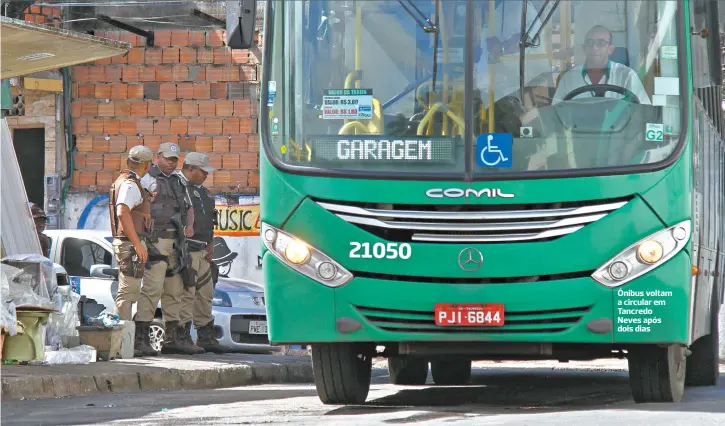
[627,345,686,403]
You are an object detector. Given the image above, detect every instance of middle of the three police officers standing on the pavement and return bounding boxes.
[136,142,202,355]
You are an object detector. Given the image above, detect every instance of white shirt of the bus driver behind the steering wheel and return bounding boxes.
[551,61,652,105]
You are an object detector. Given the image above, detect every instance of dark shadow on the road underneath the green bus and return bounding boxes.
[326,369,725,422]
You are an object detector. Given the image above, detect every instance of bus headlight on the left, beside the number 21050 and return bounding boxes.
[261,223,353,287]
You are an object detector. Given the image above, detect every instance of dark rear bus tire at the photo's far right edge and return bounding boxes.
[685,289,720,386]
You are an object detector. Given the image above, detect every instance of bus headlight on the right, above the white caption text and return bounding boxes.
[592,220,691,287]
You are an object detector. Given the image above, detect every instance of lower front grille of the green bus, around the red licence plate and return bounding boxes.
[355,306,591,335]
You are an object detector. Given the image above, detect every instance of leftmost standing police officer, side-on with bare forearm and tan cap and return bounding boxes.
[108,145,155,356]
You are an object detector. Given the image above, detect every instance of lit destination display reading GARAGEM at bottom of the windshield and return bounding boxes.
[310,136,456,163]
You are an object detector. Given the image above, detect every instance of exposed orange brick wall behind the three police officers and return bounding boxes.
[71,30,260,194]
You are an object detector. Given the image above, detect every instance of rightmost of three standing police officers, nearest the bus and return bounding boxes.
[177,152,230,353]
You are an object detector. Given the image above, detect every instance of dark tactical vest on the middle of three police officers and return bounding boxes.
[149,165,187,231]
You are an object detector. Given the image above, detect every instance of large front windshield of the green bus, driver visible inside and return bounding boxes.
[263,0,684,178]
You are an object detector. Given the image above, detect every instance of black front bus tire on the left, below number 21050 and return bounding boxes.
[312,343,373,404]
